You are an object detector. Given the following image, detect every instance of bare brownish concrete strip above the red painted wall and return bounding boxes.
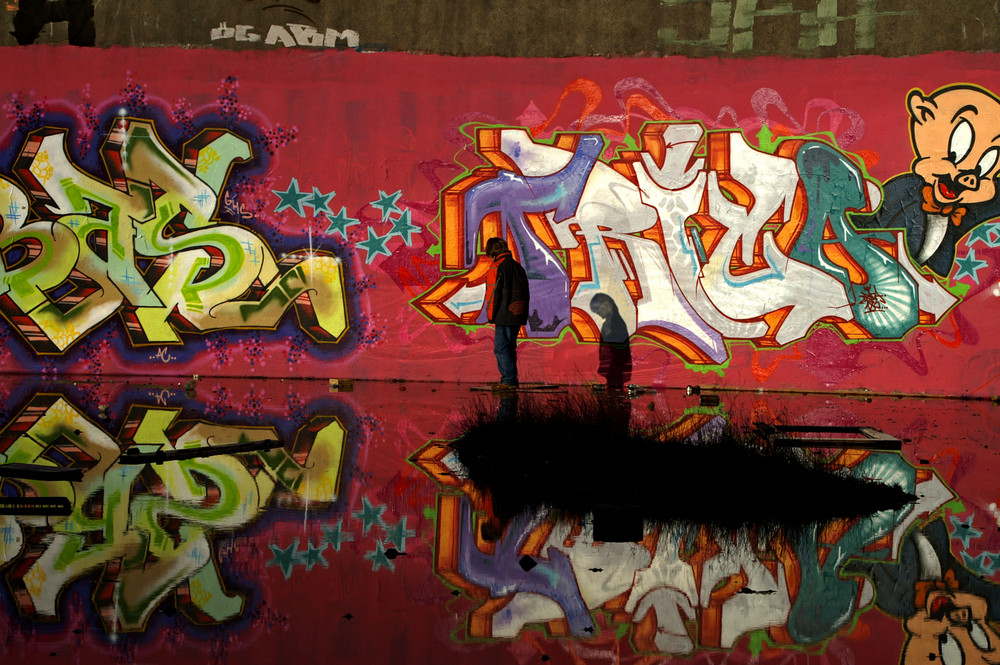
[0,0,1000,57]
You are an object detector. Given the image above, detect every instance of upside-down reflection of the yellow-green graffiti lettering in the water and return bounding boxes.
[0,395,346,632]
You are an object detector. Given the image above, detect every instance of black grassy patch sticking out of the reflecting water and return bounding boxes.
[451,396,916,536]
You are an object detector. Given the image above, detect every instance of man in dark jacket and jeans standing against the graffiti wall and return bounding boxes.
[486,238,528,389]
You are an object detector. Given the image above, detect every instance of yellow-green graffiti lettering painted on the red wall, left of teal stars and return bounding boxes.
[0,118,348,353]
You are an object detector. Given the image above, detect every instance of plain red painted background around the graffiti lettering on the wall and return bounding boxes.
[0,48,1000,396]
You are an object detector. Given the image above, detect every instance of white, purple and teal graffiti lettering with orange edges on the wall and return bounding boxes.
[414,122,955,364]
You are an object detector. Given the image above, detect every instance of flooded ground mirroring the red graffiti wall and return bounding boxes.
[0,376,1000,663]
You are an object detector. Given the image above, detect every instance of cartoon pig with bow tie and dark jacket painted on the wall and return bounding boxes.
[853,85,1000,275]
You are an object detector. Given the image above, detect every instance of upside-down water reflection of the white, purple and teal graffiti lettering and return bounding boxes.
[414,414,953,654]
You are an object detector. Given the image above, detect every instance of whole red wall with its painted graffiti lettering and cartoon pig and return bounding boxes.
[0,47,1000,397]
